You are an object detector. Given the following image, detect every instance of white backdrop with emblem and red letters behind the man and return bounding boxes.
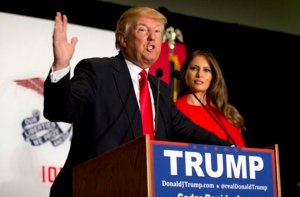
[0,12,117,197]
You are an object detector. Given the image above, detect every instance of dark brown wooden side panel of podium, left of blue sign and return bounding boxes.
[73,135,152,197]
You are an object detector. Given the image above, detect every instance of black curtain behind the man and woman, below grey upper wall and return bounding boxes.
[0,0,300,196]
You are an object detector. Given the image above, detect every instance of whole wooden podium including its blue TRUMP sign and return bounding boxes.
[73,135,281,197]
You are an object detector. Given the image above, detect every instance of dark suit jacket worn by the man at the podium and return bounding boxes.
[44,53,231,197]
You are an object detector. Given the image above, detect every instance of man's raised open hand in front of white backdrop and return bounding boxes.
[53,12,78,71]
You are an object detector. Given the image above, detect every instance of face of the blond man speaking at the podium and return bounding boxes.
[122,16,163,69]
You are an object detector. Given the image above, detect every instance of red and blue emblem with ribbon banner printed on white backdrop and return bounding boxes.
[14,78,72,147]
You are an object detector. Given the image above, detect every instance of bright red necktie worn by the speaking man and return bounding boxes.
[139,69,154,140]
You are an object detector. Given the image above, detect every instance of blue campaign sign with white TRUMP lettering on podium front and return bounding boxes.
[150,141,277,197]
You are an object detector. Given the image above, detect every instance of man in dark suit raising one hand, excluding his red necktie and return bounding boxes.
[44,7,231,197]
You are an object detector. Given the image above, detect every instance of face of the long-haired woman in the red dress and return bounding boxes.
[186,55,213,93]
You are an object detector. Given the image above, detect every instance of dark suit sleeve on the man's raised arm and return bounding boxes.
[43,60,97,123]
